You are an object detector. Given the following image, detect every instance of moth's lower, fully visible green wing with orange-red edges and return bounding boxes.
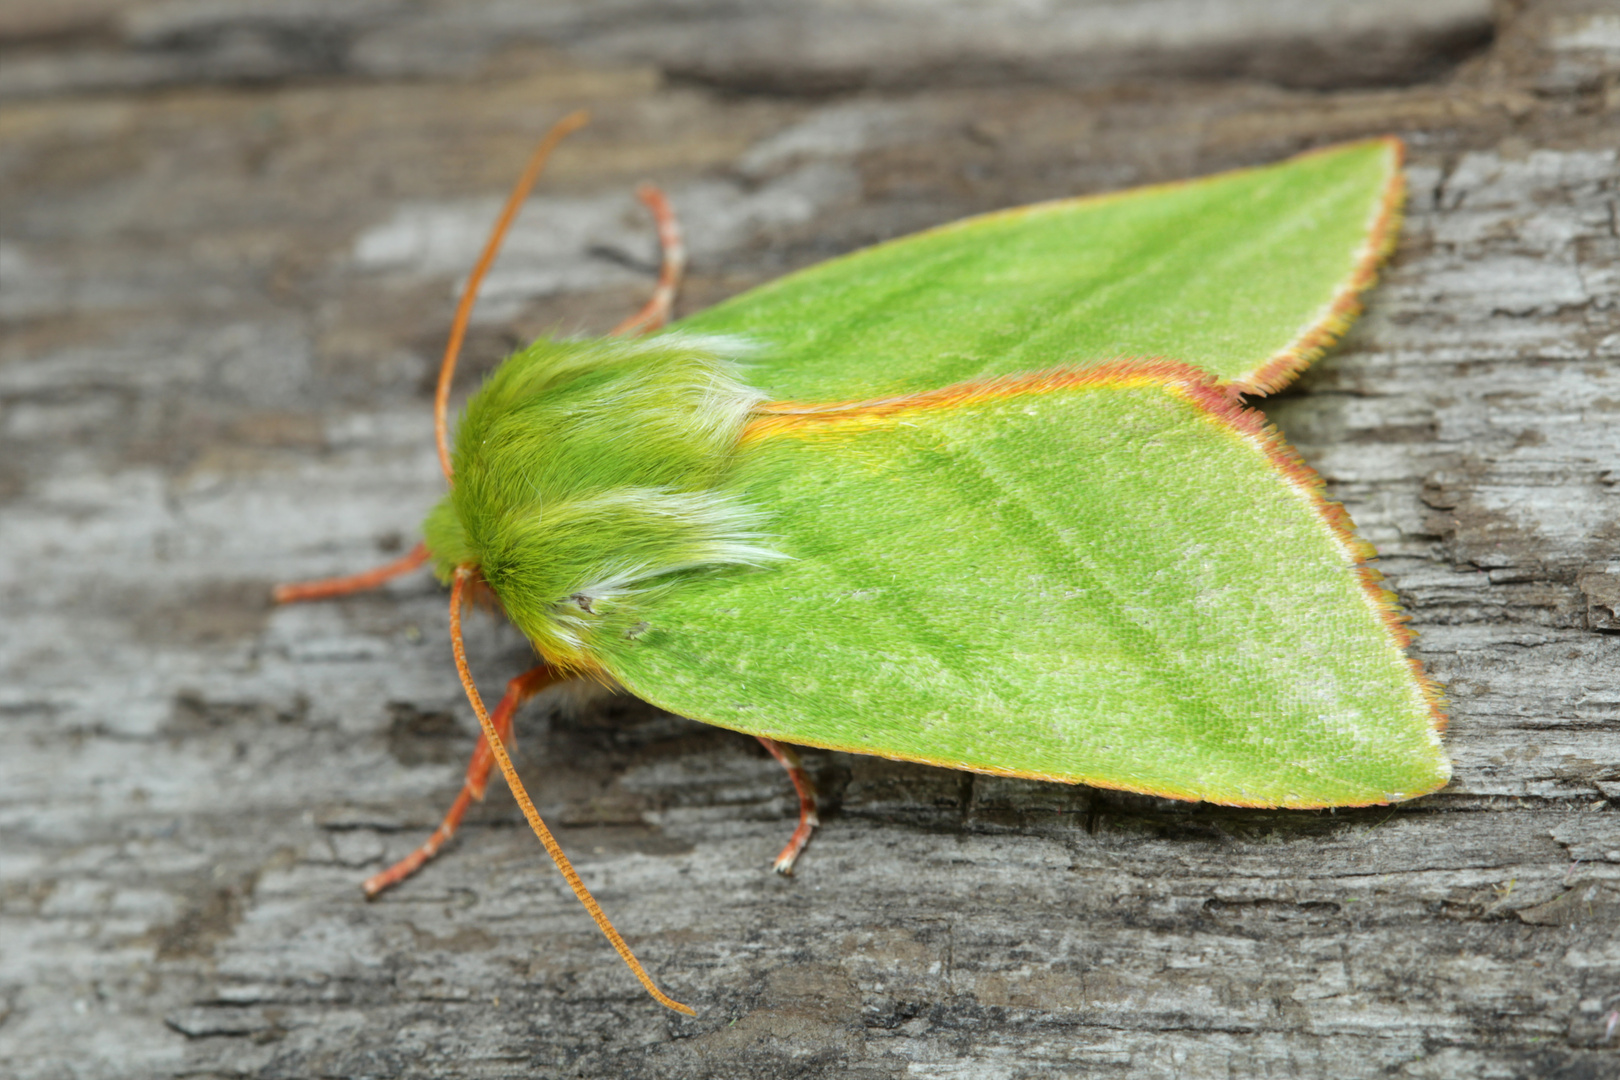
[603,375,1448,806]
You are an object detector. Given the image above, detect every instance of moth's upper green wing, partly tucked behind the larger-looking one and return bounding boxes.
[677,139,1401,400]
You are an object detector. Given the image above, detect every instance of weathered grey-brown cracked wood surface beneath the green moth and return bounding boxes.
[0,0,1620,1078]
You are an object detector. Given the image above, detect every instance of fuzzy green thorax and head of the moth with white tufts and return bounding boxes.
[423,334,782,667]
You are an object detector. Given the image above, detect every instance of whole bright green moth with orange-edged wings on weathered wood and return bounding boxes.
[275,127,1450,1004]
